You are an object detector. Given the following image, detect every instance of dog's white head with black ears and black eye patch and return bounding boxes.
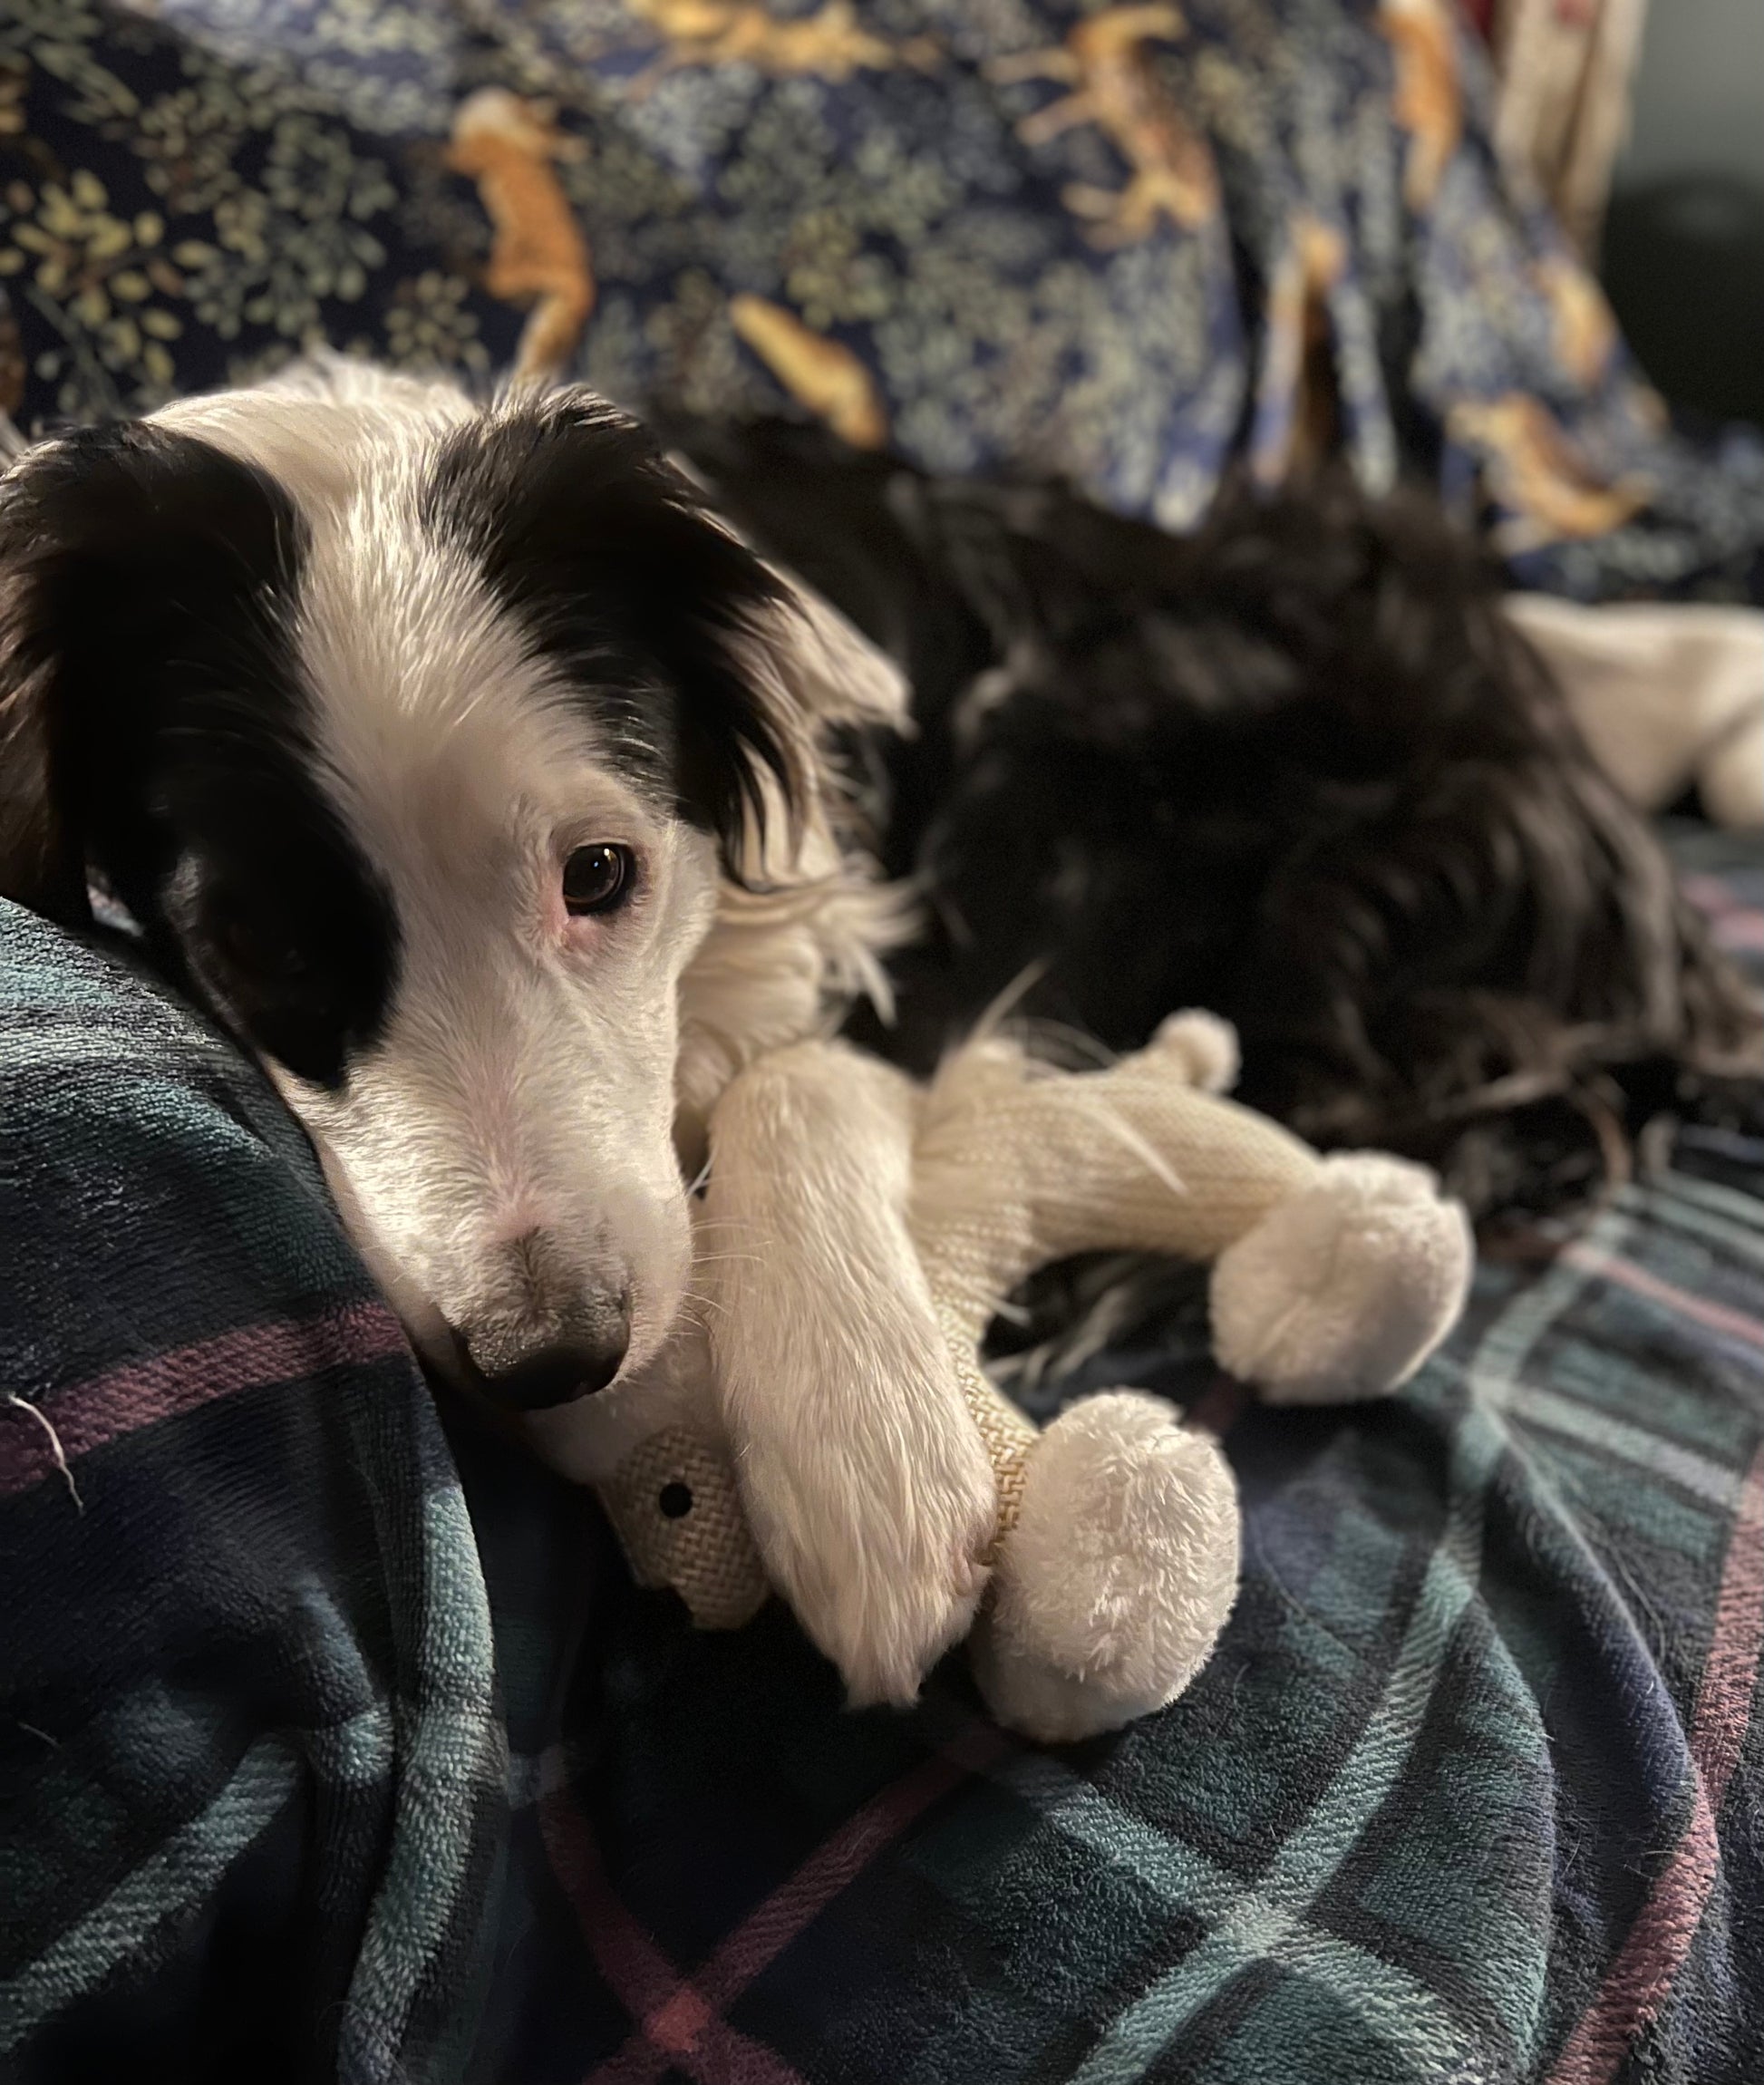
[0,377,905,1408]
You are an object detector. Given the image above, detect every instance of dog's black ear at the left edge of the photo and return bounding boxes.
[0,422,298,924]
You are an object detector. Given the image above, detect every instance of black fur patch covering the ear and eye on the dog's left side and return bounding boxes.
[0,425,398,1084]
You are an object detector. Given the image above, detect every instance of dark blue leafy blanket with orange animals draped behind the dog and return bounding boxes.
[0,0,1764,598]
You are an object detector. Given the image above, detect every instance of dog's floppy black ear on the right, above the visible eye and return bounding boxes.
[423,398,797,868]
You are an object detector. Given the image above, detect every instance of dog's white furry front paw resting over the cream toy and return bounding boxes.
[736,1324,999,1708]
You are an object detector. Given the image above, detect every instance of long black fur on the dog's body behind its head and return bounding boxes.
[675,425,1758,1214]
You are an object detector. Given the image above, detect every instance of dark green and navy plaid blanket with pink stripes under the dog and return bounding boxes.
[0,834,1764,2085]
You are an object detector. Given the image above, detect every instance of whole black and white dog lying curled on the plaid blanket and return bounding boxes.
[0,365,1751,1700]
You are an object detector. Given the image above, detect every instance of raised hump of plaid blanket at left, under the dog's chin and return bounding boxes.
[0,905,507,2080]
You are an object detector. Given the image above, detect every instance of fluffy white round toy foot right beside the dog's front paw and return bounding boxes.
[970,1391,1238,1745]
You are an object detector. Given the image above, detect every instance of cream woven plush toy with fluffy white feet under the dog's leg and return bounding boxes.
[532,1013,1472,1741]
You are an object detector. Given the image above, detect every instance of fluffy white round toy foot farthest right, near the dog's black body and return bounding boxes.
[1211,1153,1477,1405]
